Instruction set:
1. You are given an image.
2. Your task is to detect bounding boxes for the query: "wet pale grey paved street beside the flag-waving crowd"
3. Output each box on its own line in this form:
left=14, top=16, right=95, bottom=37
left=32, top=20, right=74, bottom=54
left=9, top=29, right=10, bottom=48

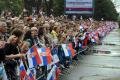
left=62, top=29, right=120, bottom=80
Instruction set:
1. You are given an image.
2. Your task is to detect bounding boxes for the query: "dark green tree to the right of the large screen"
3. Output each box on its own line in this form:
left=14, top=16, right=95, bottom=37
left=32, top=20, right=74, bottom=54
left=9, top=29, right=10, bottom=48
left=94, top=0, right=118, bottom=20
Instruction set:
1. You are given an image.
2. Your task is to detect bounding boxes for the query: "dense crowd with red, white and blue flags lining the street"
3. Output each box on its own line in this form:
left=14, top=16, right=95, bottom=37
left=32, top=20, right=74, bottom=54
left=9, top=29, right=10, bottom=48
left=0, top=11, right=118, bottom=80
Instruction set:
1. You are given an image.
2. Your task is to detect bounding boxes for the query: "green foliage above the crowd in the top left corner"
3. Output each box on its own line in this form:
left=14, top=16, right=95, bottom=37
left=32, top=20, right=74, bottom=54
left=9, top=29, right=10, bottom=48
left=0, top=0, right=23, bottom=15
